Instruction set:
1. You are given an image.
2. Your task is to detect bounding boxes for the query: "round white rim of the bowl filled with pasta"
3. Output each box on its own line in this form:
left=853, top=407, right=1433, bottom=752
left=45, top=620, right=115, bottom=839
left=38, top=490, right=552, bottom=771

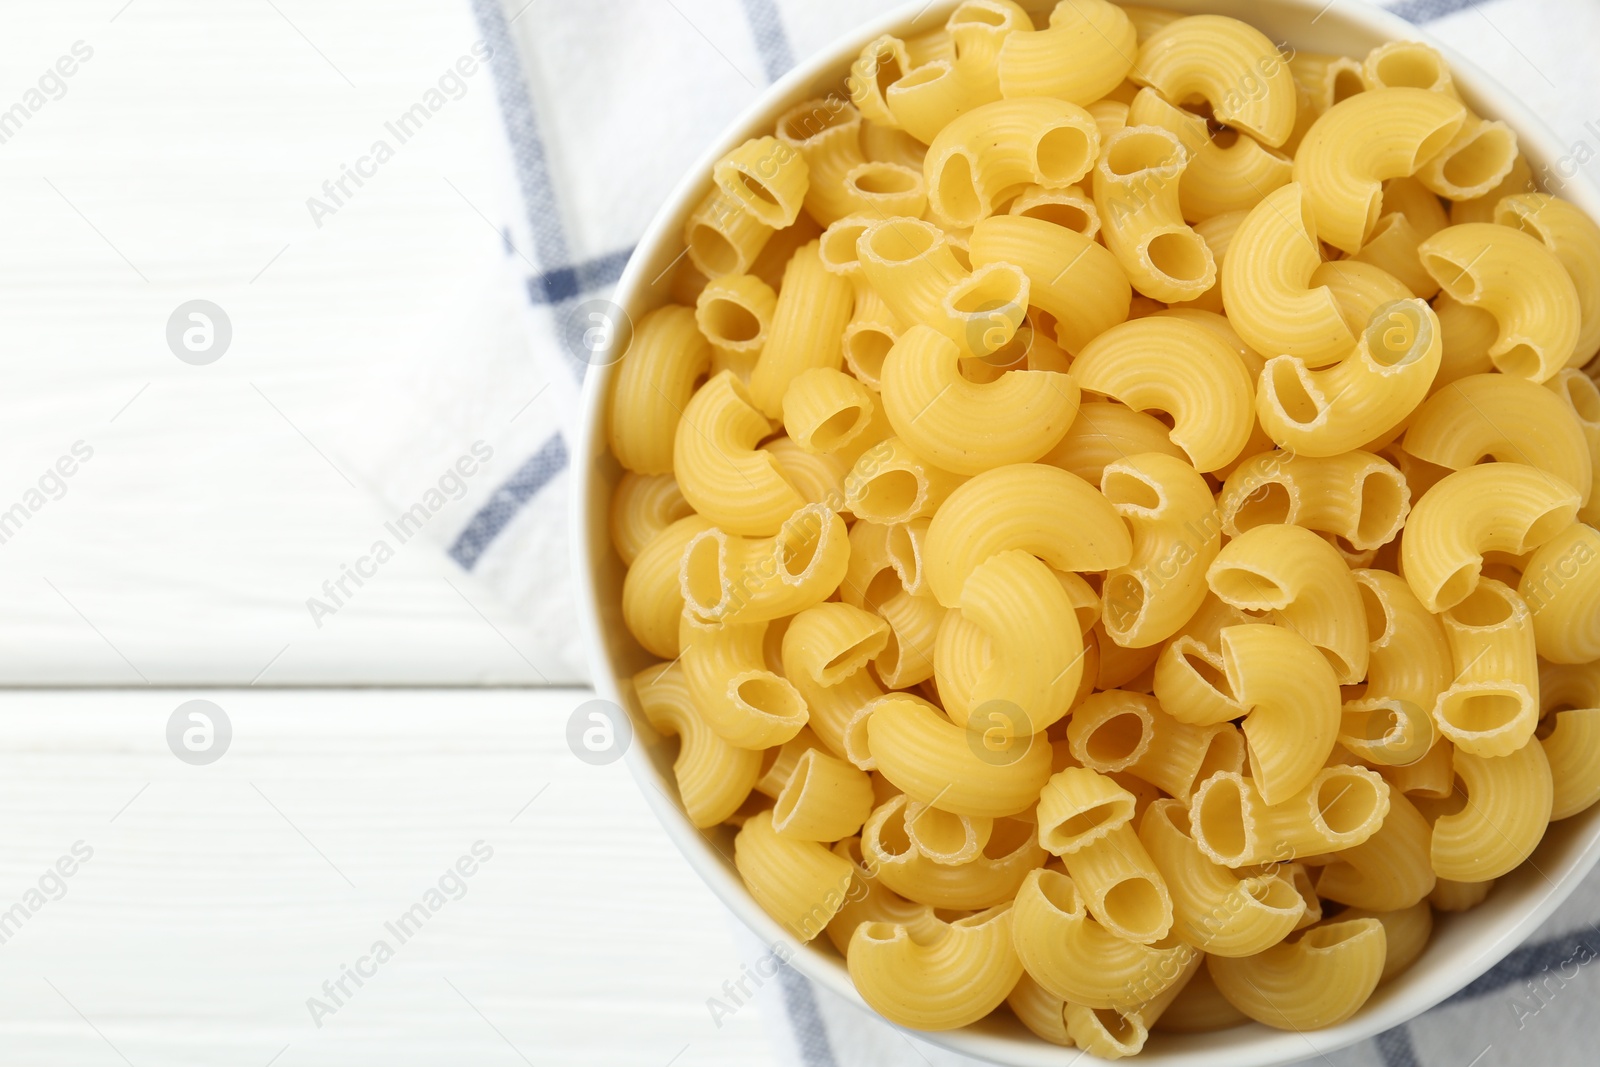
left=570, top=0, right=1600, bottom=1067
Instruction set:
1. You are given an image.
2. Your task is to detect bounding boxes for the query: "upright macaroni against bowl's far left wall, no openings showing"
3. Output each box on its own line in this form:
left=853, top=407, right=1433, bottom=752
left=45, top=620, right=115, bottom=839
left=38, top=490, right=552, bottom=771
left=606, top=307, right=710, bottom=474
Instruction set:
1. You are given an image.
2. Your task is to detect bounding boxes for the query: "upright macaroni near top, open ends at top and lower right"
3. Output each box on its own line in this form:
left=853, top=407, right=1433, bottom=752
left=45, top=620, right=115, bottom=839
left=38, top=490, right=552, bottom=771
left=1094, top=126, right=1216, bottom=302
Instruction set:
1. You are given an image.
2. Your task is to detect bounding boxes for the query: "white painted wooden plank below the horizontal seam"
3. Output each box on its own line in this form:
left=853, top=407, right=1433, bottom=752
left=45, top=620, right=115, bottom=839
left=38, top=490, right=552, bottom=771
left=0, top=689, right=771, bottom=1067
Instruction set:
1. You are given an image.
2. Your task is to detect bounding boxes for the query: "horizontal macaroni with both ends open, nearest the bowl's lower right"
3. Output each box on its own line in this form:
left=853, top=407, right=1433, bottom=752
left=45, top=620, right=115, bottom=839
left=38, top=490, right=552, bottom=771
left=1189, top=763, right=1390, bottom=867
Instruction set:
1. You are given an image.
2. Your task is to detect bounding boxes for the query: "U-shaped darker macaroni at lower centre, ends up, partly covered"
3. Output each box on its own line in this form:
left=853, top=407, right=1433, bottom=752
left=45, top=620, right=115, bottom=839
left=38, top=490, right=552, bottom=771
left=861, top=795, right=1050, bottom=909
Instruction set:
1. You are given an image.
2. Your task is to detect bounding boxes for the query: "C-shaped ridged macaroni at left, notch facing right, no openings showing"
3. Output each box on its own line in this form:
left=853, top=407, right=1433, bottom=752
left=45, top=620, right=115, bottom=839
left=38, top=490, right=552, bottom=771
left=674, top=371, right=805, bottom=536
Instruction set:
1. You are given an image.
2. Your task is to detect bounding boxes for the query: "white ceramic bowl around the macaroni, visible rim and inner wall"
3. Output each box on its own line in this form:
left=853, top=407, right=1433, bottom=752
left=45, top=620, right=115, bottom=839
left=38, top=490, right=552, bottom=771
left=573, top=0, right=1600, bottom=1067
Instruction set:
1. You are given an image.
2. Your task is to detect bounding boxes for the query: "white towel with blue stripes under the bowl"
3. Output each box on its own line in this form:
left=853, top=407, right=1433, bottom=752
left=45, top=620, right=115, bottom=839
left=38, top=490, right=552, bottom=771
left=444, top=0, right=1600, bottom=1067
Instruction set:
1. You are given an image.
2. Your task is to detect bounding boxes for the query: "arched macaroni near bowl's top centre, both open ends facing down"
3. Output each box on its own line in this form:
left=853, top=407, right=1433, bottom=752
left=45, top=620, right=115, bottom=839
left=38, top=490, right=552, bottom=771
left=923, top=96, right=1101, bottom=229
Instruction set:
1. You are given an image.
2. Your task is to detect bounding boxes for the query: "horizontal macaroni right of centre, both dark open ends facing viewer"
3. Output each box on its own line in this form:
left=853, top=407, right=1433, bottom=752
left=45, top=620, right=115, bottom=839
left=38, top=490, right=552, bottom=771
left=1218, top=451, right=1411, bottom=550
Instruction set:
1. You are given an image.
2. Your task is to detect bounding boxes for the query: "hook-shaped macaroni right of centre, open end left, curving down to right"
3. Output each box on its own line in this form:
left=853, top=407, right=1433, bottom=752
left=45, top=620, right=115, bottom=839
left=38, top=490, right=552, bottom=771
left=1206, top=525, right=1368, bottom=684
